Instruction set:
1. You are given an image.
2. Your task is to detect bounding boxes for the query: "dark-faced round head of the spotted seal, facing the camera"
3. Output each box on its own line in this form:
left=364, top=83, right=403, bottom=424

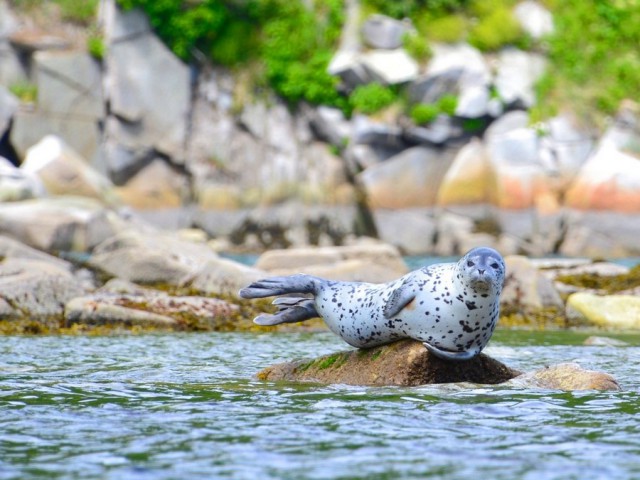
left=458, top=247, right=505, bottom=294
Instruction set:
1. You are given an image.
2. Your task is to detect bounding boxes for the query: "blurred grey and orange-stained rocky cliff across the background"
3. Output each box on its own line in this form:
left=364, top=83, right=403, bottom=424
left=0, top=0, right=640, bottom=256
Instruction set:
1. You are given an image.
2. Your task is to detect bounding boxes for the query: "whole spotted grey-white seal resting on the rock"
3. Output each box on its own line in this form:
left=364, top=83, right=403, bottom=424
left=239, top=247, right=505, bottom=360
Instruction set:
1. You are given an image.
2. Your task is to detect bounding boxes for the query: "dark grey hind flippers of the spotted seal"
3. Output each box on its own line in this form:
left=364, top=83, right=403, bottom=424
left=239, top=274, right=325, bottom=325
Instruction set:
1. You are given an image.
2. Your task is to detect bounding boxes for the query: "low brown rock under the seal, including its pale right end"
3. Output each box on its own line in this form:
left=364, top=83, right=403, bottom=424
left=257, top=340, right=620, bottom=391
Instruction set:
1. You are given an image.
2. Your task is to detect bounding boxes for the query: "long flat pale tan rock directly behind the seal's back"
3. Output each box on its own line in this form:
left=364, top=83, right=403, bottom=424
left=255, top=244, right=408, bottom=283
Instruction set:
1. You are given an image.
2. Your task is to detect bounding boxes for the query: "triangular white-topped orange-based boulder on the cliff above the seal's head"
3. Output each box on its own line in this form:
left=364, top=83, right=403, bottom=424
left=437, top=139, right=494, bottom=207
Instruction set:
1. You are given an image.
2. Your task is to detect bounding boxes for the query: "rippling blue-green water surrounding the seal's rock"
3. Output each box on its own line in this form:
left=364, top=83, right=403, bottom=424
left=0, top=331, right=640, bottom=480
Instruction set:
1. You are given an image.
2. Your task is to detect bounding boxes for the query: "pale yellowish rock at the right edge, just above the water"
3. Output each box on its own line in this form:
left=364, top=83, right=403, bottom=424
left=566, top=292, right=640, bottom=330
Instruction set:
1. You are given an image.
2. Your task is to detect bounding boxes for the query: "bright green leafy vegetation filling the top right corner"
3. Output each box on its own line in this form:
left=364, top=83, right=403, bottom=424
left=534, top=0, right=640, bottom=125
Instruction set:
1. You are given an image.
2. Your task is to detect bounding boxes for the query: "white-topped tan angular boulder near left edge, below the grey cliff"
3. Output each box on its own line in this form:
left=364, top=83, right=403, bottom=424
left=20, top=135, right=118, bottom=205
